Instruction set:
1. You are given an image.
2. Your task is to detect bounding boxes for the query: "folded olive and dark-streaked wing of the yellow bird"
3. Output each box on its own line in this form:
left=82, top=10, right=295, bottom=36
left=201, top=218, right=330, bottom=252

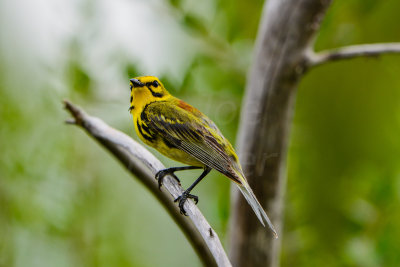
left=141, top=102, right=242, bottom=184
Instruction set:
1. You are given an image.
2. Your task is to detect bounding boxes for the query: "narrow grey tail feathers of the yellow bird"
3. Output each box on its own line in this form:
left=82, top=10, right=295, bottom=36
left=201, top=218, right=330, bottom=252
left=236, top=179, right=278, bottom=238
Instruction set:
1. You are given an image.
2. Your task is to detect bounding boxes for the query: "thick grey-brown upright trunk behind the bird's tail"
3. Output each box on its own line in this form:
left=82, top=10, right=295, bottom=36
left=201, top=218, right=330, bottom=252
left=230, top=0, right=331, bottom=267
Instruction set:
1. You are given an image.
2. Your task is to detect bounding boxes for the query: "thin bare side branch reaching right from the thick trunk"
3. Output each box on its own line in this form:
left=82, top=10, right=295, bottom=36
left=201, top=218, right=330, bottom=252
left=306, top=43, right=400, bottom=67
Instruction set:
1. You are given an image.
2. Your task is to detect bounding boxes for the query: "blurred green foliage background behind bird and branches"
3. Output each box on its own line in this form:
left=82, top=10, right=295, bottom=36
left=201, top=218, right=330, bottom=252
left=0, top=0, right=400, bottom=266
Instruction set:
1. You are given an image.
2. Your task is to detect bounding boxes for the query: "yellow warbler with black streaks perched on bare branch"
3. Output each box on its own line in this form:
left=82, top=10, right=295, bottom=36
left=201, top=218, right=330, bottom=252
left=129, top=76, right=277, bottom=237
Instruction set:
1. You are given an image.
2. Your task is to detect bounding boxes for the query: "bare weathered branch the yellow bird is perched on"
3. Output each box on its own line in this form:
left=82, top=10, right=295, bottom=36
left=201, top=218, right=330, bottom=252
left=64, top=100, right=231, bottom=266
